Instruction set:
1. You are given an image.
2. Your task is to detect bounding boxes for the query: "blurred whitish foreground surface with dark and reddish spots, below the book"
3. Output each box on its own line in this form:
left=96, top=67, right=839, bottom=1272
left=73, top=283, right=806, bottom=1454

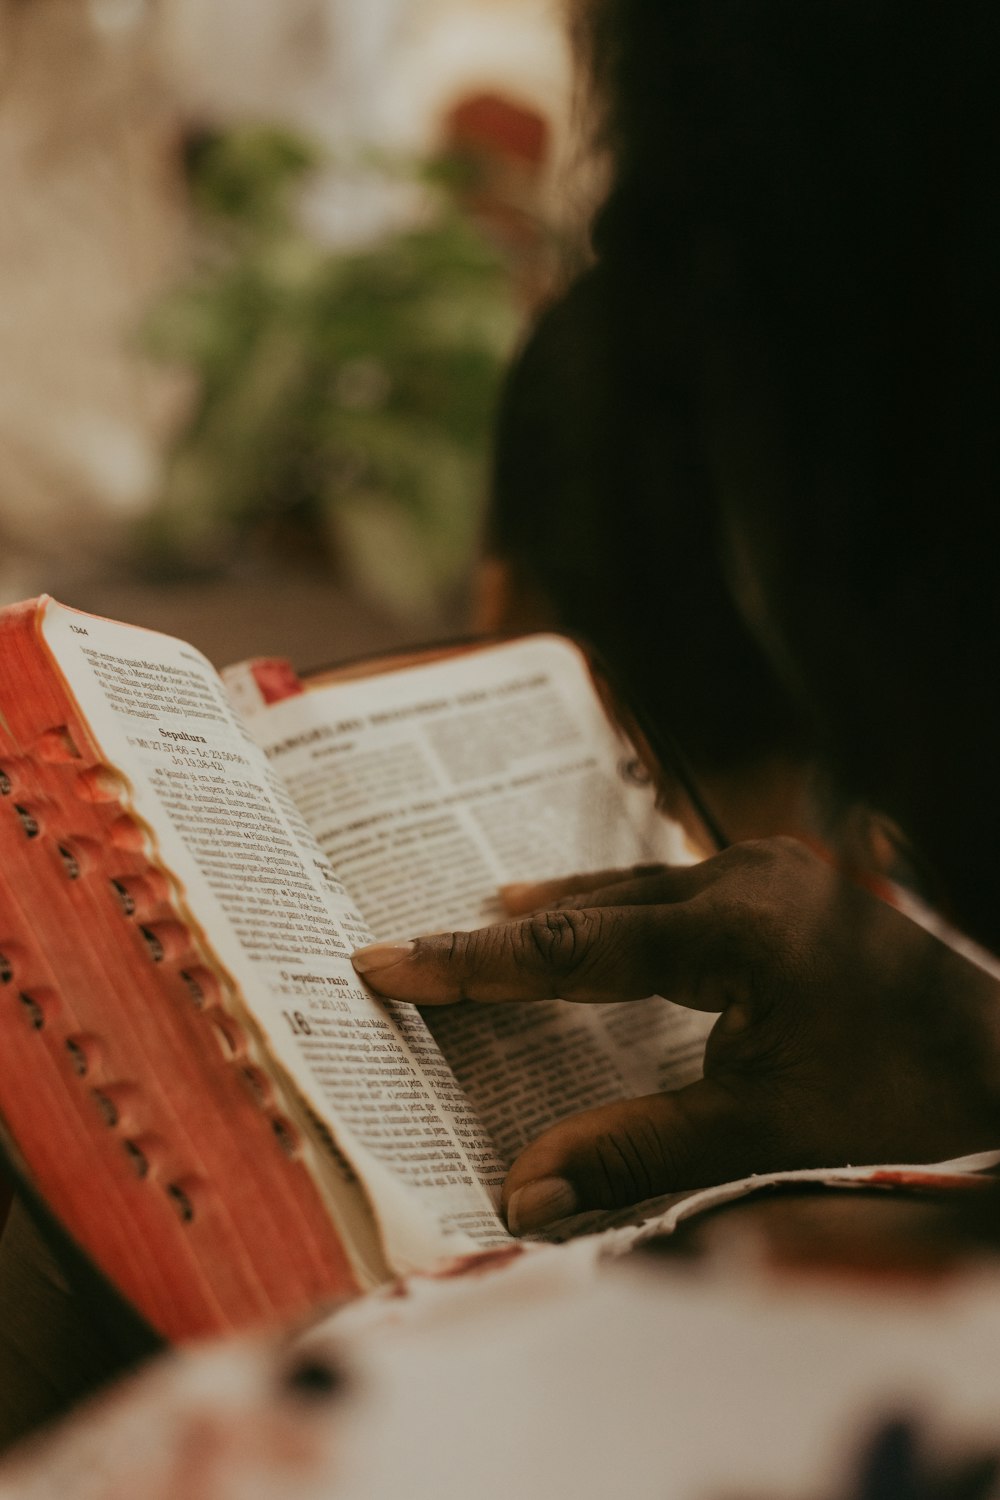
left=0, top=1191, right=1000, bottom=1500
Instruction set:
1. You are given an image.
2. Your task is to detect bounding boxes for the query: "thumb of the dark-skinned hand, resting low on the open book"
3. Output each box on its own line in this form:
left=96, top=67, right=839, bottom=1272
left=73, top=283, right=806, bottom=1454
left=502, top=1079, right=772, bottom=1235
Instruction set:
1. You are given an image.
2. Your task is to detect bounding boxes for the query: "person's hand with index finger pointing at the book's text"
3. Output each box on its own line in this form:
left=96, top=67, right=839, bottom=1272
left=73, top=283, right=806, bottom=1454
left=355, top=839, right=1000, bottom=1232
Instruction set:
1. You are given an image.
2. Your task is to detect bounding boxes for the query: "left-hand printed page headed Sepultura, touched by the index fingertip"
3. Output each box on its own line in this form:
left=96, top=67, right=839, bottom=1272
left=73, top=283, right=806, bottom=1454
left=42, top=600, right=508, bottom=1269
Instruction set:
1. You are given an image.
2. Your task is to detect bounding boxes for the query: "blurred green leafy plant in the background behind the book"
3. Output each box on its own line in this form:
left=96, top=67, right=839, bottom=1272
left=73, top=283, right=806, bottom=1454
left=139, top=128, right=519, bottom=615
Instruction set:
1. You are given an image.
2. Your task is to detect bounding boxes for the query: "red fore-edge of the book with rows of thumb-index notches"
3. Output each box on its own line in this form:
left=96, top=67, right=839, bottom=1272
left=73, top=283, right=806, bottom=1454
left=0, top=606, right=358, bottom=1338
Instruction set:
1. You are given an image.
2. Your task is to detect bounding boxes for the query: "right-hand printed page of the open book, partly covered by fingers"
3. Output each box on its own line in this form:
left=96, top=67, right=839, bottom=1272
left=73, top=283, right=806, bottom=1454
left=235, top=636, right=714, bottom=1163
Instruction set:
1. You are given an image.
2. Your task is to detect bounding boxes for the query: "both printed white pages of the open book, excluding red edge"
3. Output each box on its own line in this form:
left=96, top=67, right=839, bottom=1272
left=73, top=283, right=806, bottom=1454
left=0, top=600, right=711, bottom=1338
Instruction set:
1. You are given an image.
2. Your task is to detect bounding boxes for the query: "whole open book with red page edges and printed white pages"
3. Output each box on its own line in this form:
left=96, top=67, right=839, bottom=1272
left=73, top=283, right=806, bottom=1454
left=0, top=599, right=711, bottom=1338
